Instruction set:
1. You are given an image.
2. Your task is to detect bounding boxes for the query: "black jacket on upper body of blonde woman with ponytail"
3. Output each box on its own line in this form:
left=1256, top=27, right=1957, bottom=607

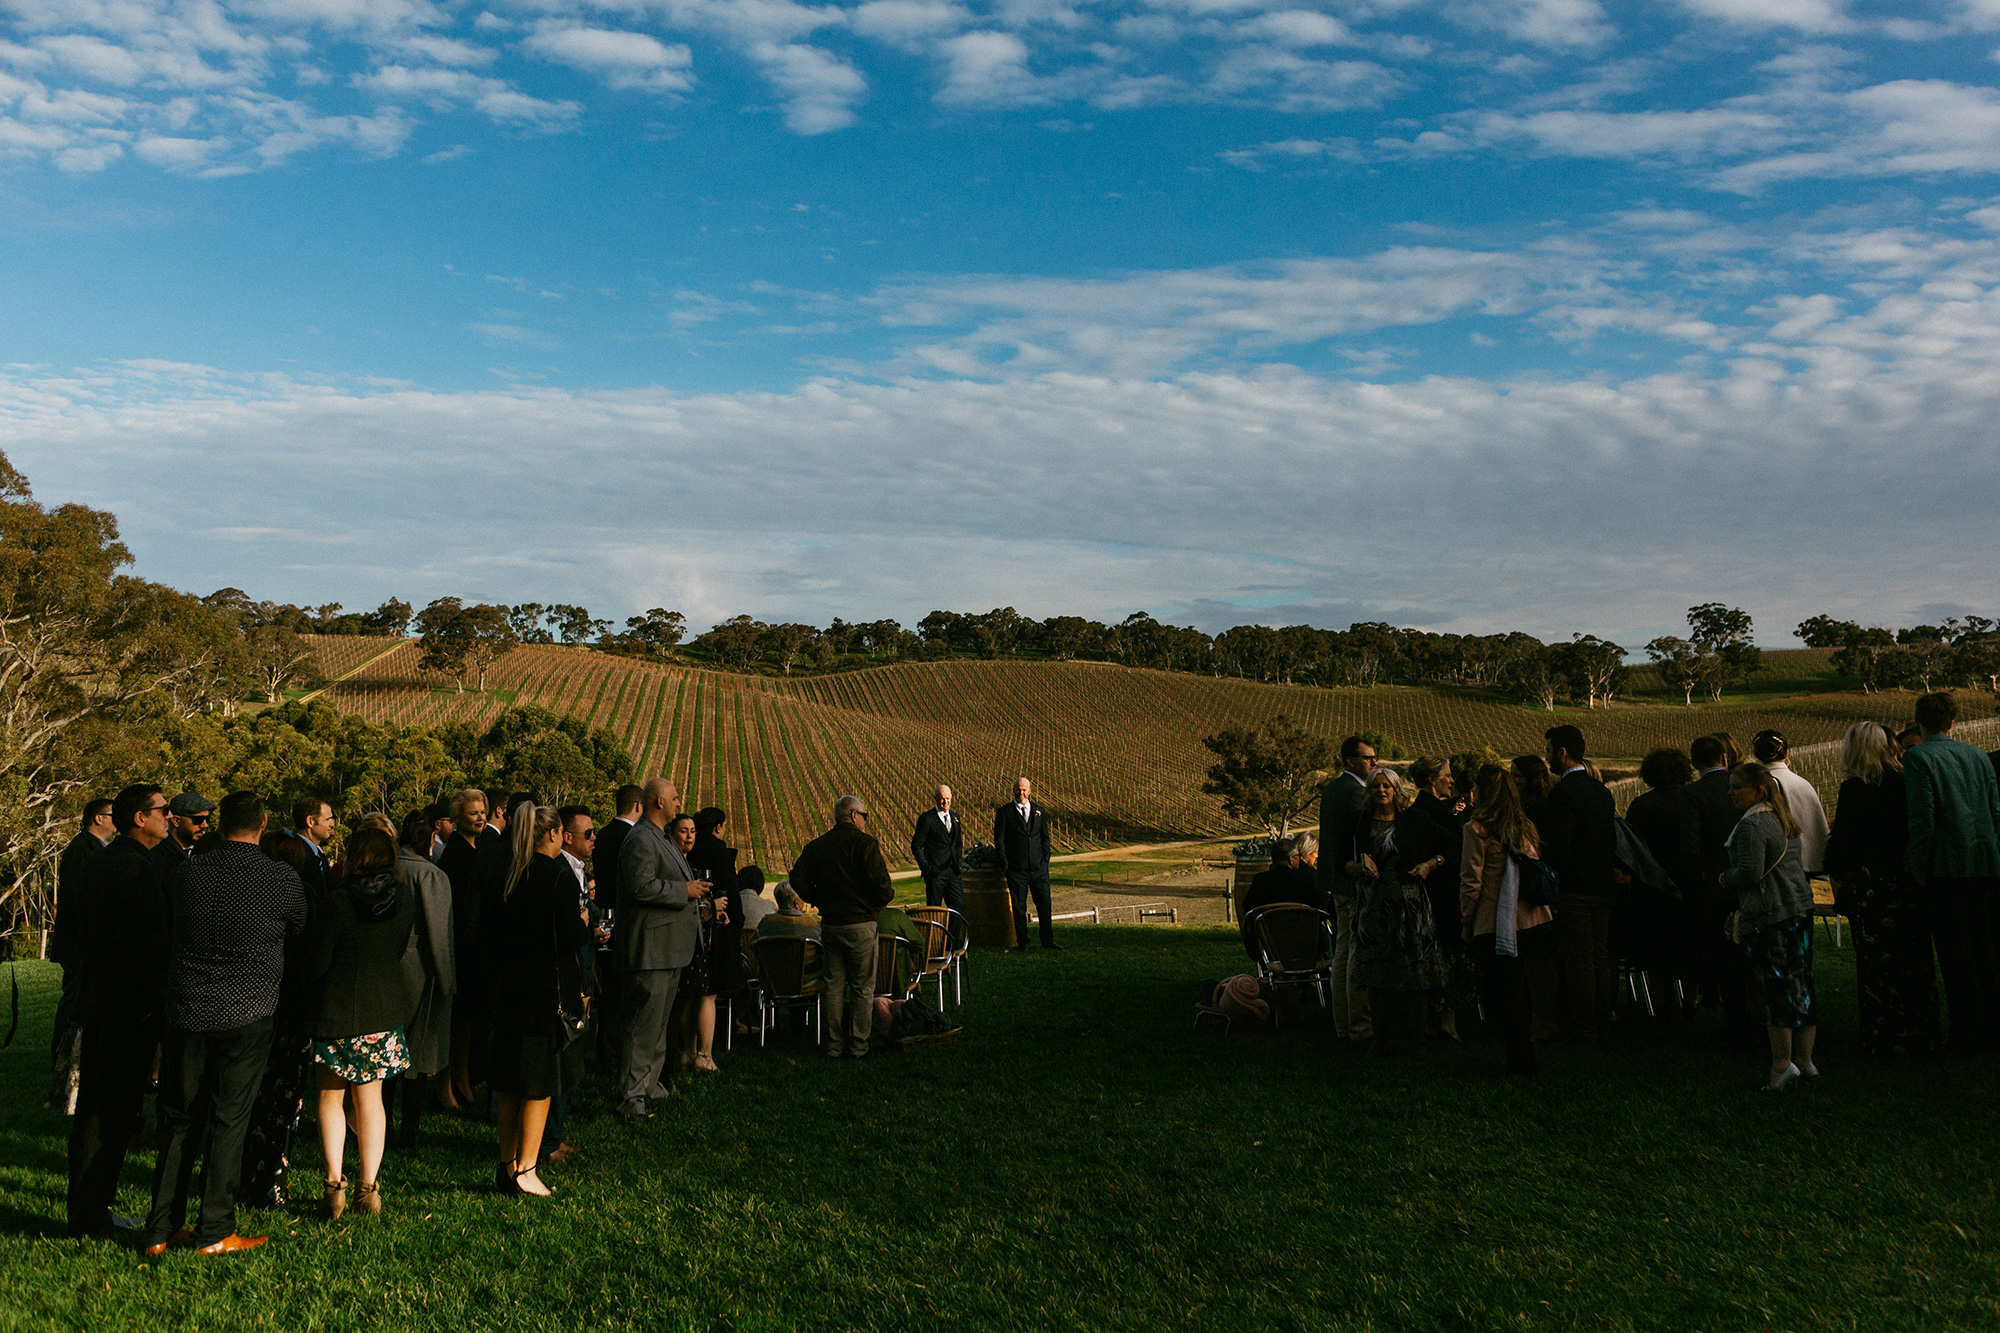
left=492, top=857, right=590, bottom=1037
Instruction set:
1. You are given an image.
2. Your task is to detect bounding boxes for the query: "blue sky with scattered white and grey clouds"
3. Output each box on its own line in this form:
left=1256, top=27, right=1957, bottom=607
left=0, top=0, right=2000, bottom=642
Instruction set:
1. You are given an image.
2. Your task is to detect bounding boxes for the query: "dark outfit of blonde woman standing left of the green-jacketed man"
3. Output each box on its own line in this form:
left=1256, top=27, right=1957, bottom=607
left=1826, top=773, right=1938, bottom=1055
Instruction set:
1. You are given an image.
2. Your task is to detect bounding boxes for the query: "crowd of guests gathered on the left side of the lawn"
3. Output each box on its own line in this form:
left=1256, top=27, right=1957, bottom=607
left=50, top=779, right=924, bottom=1255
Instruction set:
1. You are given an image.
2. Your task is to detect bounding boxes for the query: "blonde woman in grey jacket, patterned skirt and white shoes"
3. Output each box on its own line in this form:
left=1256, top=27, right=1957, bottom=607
left=1722, top=763, right=1820, bottom=1093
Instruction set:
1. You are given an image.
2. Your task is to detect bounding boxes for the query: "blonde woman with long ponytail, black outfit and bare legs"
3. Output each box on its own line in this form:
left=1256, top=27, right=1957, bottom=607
left=486, top=805, right=590, bottom=1197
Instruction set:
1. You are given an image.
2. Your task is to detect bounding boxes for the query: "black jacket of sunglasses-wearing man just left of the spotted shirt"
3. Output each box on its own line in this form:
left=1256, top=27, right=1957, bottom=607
left=76, top=837, right=174, bottom=1020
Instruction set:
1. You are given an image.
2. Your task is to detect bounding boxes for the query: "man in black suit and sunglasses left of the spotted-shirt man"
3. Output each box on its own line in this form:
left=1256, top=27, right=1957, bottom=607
left=70, top=783, right=172, bottom=1235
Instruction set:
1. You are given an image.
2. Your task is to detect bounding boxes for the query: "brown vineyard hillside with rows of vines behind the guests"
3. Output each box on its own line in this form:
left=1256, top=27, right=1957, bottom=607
left=322, top=636, right=1992, bottom=867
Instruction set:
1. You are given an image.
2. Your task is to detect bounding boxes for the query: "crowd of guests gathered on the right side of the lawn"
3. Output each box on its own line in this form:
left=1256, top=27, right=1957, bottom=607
left=1214, top=693, right=2000, bottom=1091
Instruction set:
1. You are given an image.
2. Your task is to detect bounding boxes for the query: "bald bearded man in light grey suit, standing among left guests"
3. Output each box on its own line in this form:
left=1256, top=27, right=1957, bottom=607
left=612, top=779, right=708, bottom=1121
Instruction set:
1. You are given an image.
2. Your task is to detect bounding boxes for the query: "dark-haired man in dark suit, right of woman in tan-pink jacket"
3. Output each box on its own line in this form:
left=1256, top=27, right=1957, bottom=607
left=1540, top=725, right=1618, bottom=1047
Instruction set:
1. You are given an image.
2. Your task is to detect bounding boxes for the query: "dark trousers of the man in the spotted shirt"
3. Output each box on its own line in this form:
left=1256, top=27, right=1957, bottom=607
left=146, top=1019, right=272, bottom=1245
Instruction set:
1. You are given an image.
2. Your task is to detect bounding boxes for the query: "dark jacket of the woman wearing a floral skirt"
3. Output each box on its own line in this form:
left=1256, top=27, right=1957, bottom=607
left=306, top=873, right=424, bottom=1041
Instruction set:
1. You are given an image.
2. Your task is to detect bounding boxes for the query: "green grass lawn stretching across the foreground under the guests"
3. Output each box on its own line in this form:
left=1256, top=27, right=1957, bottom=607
left=0, top=927, right=2000, bottom=1331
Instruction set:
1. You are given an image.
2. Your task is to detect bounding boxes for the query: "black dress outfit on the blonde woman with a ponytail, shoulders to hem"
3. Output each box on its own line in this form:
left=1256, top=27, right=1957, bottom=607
left=486, top=855, right=590, bottom=1101
